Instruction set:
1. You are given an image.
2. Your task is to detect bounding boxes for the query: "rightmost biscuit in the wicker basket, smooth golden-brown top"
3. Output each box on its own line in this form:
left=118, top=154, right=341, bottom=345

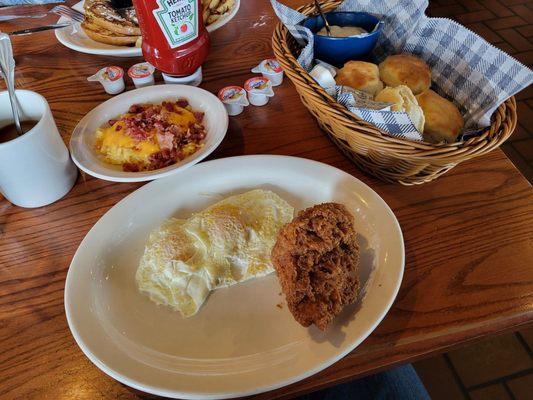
left=416, top=90, right=464, bottom=143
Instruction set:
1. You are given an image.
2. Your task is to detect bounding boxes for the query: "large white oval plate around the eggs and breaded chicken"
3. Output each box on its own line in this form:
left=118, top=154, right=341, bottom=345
left=65, top=155, right=404, bottom=399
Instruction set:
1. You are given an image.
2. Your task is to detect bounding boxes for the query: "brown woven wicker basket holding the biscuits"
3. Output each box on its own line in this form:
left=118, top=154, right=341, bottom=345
left=272, top=0, right=517, bottom=185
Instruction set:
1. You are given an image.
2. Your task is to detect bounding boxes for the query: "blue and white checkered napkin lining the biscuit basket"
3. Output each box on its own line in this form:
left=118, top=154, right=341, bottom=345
left=271, top=0, right=533, bottom=140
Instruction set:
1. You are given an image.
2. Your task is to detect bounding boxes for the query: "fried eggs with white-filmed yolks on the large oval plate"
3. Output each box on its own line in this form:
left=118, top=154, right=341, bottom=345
left=136, top=189, right=294, bottom=317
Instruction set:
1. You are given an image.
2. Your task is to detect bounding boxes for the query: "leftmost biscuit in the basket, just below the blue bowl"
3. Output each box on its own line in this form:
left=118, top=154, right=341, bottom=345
left=335, top=61, right=383, bottom=96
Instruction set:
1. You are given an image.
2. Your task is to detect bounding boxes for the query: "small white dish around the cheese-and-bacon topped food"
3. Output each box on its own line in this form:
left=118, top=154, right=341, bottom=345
left=70, top=85, right=228, bottom=182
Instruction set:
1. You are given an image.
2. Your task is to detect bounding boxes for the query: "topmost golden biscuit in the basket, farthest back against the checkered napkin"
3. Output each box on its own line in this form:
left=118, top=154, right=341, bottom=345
left=379, top=54, right=431, bottom=95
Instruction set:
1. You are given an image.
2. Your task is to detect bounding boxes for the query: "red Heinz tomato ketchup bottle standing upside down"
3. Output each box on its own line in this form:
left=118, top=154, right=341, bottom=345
left=133, top=0, right=209, bottom=81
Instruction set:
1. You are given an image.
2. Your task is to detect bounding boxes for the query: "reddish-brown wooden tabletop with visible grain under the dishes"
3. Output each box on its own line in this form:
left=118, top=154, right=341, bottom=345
left=0, top=0, right=533, bottom=399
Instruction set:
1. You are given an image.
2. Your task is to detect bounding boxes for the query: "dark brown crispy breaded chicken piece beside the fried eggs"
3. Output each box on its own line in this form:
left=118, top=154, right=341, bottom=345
left=272, top=203, right=359, bottom=330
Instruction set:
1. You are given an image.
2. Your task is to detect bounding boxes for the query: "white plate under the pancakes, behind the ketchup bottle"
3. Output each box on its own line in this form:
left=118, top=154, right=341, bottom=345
left=55, top=0, right=241, bottom=57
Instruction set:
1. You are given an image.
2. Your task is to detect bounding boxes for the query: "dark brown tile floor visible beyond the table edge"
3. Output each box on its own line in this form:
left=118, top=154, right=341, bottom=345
left=414, top=0, right=533, bottom=400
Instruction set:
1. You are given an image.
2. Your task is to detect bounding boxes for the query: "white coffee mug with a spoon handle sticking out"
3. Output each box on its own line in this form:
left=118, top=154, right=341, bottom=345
left=0, top=90, right=78, bottom=208
